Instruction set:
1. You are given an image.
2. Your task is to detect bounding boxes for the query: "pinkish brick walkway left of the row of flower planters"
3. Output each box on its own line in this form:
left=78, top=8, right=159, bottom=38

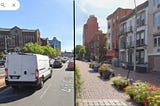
left=76, top=61, right=136, bottom=106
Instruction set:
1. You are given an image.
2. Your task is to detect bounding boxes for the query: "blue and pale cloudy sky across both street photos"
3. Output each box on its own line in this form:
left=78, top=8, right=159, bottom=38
left=0, top=0, right=146, bottom=52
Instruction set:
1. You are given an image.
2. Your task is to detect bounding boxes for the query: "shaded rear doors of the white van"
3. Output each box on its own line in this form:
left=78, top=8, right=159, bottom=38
left=7, top=55, right=36, bottom=82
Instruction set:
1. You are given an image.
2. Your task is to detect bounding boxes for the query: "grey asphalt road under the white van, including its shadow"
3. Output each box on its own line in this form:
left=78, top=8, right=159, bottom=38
left=0, top=62, right=74, bottom=106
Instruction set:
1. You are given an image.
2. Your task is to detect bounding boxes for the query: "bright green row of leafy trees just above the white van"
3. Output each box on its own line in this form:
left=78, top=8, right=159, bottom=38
left=23, top=43, right=59, bottom=57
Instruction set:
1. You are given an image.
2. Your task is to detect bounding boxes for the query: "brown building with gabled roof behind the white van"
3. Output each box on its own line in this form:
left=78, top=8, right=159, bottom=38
left=0, top=26, right=41, bottom=51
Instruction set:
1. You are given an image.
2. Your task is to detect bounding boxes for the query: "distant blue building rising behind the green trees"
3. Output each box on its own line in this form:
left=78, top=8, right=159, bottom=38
left=49, top=37, right=61, bottom=52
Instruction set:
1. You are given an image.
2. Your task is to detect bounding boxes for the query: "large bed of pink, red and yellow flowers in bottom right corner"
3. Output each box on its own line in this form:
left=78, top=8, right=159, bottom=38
left=125, top=81, right=160, bottom=106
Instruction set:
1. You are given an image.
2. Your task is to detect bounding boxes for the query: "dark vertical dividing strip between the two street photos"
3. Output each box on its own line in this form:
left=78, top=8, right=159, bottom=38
left=73, top=0, right=76, bottom=106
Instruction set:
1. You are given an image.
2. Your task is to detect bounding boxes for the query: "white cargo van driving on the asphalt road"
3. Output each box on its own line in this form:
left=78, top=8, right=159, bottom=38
left=5, top=53, right=52, bottom=88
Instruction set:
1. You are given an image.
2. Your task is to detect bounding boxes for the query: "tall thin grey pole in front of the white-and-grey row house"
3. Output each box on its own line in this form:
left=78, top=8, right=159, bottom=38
left=133, top=0, right=137, bottom=81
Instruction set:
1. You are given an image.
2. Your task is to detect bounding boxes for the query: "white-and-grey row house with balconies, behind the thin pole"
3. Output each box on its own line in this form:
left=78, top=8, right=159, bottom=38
left=119, top=1, right=148, bottom=71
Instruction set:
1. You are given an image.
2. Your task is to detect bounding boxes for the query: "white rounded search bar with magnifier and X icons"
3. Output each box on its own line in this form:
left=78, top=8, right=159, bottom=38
left=0, top=0, right=20, bottom=10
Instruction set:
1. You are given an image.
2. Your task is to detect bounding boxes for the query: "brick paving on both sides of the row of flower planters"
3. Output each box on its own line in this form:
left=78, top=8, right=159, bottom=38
left=76, top=61, right=160, bottom=106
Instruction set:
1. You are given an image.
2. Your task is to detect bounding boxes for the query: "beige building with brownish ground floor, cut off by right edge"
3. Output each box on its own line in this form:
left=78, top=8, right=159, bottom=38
left=148, top=0, right=160, bottom=71
